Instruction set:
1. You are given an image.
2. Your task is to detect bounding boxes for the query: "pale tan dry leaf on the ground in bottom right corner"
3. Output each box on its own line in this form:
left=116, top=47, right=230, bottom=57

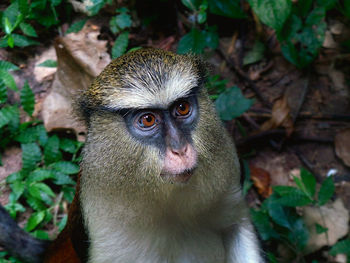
left=303, top=199, right=349, bottom=253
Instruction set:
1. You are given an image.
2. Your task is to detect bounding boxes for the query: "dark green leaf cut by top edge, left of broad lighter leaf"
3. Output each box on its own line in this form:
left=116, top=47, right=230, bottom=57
left=208, top=0, right=246, bottom=18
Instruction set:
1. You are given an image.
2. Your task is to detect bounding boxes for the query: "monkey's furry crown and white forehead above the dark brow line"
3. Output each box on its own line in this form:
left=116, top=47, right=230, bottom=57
left=86, top=49, right=205, bottom=109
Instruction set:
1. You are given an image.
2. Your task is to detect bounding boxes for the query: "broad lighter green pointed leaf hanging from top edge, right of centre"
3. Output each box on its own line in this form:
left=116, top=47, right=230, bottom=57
left=248, top=0, right=292, bottom=31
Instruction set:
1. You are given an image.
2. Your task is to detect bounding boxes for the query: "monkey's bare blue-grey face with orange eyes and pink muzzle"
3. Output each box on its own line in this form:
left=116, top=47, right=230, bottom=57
left=123, top=90, right=198, bottom=182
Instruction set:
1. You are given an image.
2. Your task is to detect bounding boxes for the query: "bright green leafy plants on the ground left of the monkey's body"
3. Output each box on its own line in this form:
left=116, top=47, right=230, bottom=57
left=0, top=61, right=82, bottom=245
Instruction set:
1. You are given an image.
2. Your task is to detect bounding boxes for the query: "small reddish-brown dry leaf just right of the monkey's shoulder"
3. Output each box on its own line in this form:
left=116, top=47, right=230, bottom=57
left=249, top=166, right=272, bottom=198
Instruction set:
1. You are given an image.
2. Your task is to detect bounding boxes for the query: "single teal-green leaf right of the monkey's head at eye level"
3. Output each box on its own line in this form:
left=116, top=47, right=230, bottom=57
left=215, top=86, right=254, bottom=121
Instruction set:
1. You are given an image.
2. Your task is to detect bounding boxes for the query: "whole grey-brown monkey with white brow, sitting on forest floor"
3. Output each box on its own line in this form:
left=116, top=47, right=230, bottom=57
left=0, top=48, right=264, bottom=263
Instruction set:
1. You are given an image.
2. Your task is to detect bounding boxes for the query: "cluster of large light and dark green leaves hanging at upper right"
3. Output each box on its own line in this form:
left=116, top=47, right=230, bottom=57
left=248, top=0, right=332, bottom=69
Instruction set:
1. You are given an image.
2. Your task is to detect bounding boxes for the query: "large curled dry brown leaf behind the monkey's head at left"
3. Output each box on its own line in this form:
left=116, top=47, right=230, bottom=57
left=42, top=22, right=111, bottom=140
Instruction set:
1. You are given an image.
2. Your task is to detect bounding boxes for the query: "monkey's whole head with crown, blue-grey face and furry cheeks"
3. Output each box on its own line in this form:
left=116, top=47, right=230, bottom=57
left=80, top=49, right=238, bottom=200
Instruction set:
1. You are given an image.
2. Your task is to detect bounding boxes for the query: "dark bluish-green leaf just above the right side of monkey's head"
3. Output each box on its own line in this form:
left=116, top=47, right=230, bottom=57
left=177, top=28, right=207, bottom=54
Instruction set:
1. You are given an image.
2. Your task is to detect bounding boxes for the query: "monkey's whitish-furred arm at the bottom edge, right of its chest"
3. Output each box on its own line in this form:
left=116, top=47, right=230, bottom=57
left=224, top=222, right=264, bottom=263
